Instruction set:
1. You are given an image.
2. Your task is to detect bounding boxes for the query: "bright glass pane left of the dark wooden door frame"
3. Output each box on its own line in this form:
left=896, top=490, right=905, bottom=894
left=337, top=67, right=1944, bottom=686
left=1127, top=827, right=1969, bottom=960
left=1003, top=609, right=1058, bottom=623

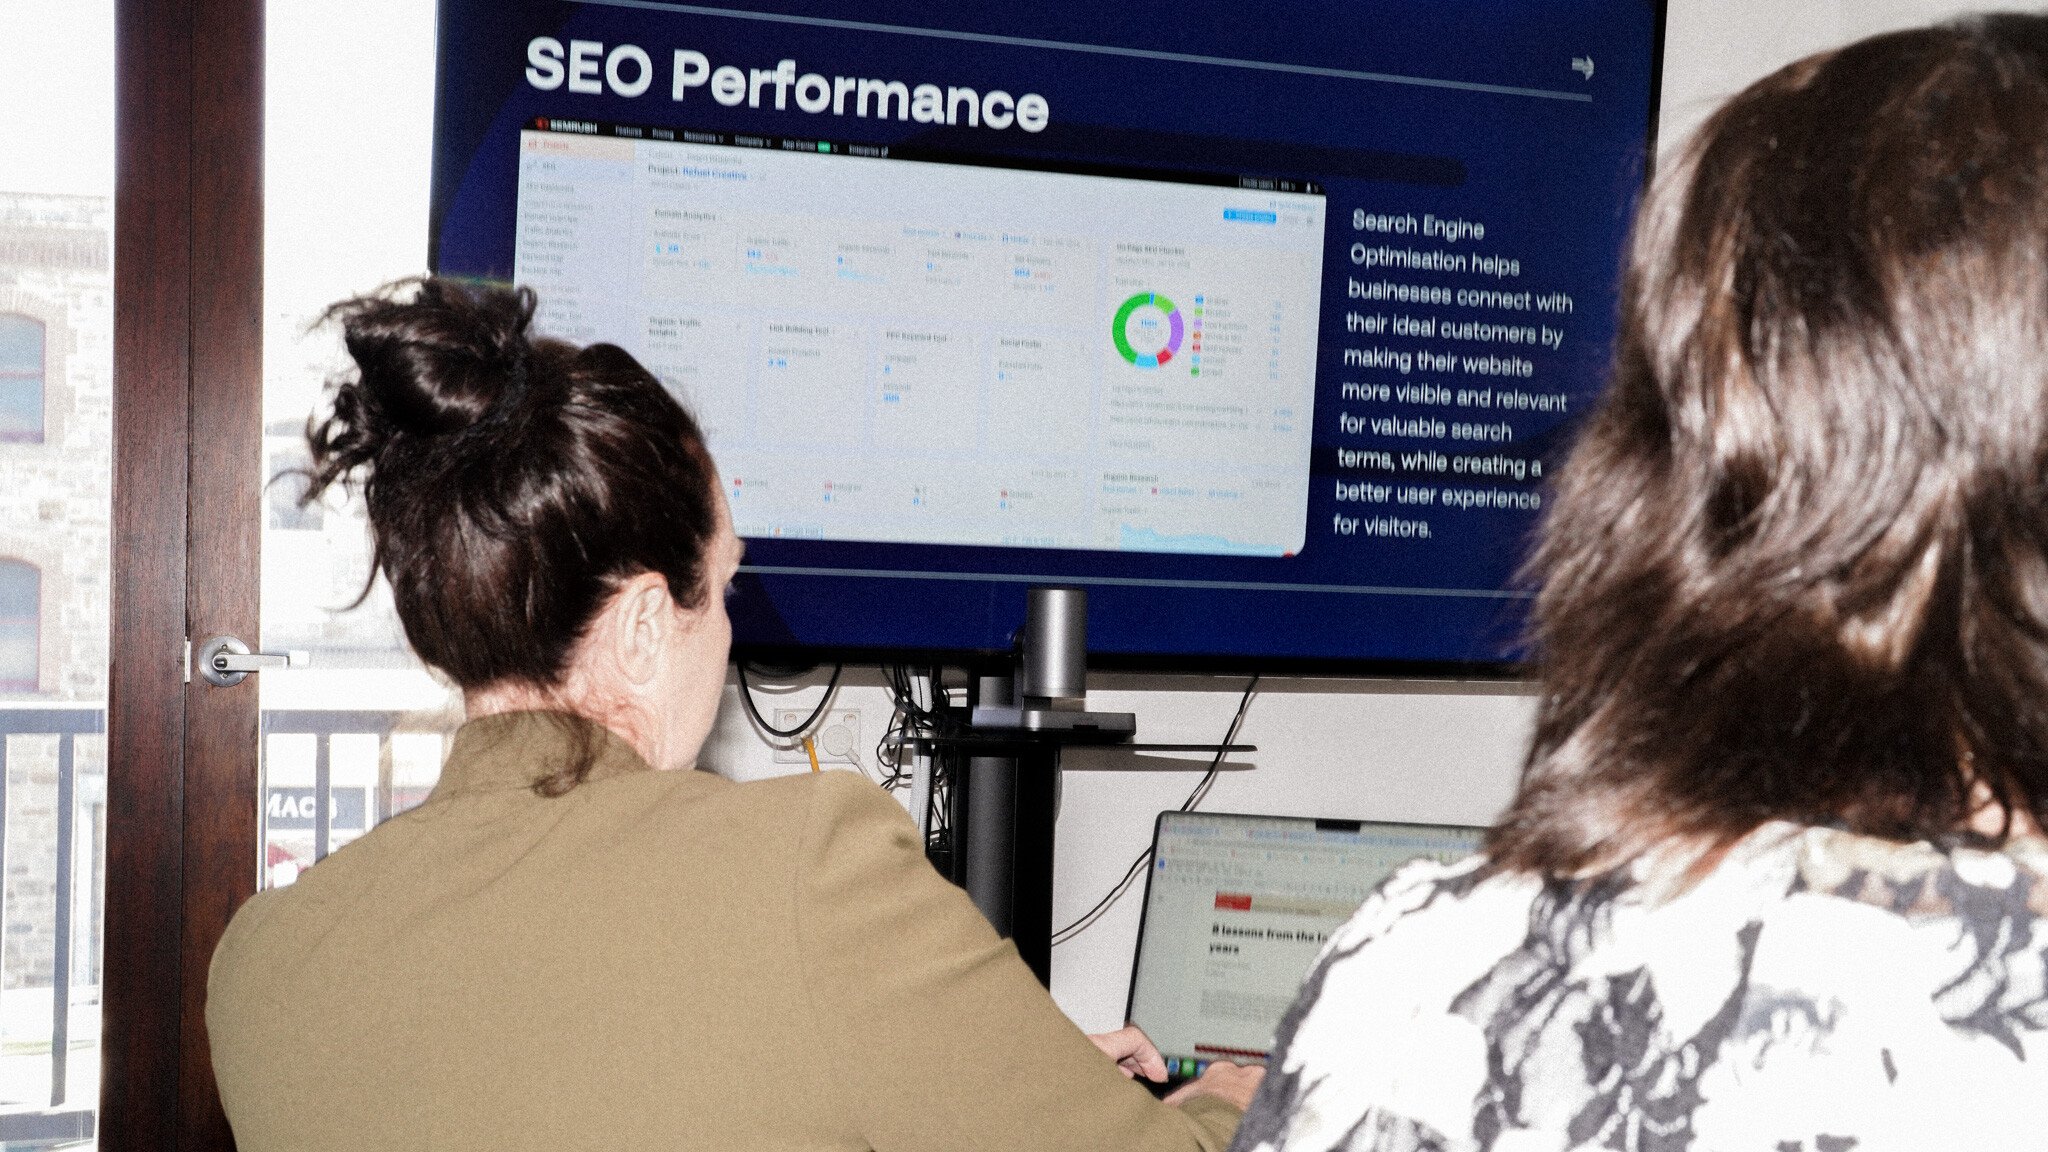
left=0, top=0, right=115, bottom=1131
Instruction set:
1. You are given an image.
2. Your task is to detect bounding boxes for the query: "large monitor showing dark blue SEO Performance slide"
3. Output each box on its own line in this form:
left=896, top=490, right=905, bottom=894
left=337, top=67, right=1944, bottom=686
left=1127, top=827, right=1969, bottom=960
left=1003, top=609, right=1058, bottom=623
left=432, top=0, right=1663, bottom=672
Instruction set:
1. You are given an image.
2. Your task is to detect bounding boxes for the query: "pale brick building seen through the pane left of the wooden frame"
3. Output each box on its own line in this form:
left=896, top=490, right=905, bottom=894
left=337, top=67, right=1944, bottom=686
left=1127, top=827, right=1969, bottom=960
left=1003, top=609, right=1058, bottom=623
left=0, top=193, right=113, bottom=988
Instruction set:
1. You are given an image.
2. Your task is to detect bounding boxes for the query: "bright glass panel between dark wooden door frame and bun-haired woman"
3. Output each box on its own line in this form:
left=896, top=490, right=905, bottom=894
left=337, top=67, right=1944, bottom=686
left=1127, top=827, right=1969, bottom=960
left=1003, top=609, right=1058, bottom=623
left=258, top=0, right=448, bottom=888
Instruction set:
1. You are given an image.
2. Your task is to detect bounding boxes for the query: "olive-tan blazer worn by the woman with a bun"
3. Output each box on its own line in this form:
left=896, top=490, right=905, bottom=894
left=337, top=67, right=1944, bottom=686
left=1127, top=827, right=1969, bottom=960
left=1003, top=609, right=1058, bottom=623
left=207, top=713, right=1237, bottom=1152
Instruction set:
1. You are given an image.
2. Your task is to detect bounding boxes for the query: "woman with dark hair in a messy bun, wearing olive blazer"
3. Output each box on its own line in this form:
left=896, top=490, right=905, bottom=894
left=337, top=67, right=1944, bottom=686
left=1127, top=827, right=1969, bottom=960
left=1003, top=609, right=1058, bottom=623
left=207, top=279, right=1260, bottom=1152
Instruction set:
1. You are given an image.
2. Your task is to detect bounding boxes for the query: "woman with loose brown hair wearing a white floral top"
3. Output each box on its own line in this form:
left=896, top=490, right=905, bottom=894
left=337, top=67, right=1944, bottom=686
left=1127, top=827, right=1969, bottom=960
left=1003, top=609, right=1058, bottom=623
left=1235, top=16, right=2048, bottom=1152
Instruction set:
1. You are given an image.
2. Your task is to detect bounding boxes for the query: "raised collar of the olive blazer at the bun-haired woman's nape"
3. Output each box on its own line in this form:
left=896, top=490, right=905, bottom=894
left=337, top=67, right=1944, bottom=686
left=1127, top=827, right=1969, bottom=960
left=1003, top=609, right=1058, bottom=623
left=426, top=711, right=653, bottom=801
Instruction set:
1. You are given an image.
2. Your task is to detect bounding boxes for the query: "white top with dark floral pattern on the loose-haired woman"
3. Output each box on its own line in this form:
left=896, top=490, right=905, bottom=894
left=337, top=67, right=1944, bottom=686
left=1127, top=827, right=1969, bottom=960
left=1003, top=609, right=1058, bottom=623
left=1231, top=824, right=2048, bottom=1152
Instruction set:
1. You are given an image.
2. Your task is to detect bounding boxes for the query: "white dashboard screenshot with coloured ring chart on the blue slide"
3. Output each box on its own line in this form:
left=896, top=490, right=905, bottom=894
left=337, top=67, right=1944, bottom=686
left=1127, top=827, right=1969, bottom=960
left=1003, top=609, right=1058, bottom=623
left=514, top=125, right=1325, bottom=556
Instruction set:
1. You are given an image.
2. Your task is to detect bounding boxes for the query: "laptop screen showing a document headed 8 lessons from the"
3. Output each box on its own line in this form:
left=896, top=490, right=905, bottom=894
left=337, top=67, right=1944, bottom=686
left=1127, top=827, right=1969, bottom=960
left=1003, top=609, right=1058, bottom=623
left=1128, top=812, right=1487, bottom=1076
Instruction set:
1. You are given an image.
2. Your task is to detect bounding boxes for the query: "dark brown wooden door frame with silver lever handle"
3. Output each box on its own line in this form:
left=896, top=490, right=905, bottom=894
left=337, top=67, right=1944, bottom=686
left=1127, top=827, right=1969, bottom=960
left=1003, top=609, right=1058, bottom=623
left=98, top=0, right=264, bottom=1152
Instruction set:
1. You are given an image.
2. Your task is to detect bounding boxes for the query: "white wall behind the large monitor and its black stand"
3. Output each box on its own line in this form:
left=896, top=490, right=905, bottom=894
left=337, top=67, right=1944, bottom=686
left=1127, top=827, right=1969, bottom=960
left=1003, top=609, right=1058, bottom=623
left=707, top=0, right=1976, bottom=1031
